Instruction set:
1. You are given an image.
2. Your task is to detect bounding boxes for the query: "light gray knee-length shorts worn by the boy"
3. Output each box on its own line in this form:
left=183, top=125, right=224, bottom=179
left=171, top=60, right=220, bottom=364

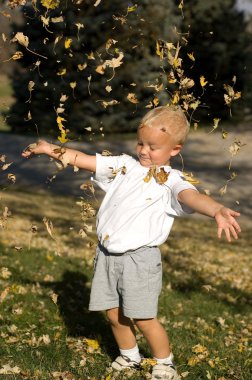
left=89, top=246, right=162, bottom=319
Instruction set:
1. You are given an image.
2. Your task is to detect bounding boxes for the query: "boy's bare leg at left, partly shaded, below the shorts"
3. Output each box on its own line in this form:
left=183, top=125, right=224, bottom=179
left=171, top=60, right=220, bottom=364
left=106, top=307, right=136, bottom=350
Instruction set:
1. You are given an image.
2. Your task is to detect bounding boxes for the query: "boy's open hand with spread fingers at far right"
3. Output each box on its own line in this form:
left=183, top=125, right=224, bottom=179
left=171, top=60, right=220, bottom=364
left=214, top=206, right=241, bottom=242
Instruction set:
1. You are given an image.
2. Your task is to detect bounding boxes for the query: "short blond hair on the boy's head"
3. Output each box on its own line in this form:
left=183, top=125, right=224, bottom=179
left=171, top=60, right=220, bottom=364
left=139, top=106, right=190, bottom=144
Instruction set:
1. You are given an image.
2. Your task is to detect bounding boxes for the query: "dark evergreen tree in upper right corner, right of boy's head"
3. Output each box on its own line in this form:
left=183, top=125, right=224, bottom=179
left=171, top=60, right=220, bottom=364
left=177, top=0, right=251, bottom=119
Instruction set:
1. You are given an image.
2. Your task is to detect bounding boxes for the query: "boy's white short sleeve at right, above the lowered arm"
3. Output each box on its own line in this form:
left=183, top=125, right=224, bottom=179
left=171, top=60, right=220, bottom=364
left=166, top=170, right=198, bottom=216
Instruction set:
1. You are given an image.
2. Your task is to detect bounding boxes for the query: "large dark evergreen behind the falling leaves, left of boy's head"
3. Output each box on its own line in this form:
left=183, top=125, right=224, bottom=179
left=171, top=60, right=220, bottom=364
left=8, top=0, right=177, bottom=135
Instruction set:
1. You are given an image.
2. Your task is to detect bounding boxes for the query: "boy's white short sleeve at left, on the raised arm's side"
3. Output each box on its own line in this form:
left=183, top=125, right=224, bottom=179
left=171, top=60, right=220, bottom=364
left=93, top=154, right=131, bottom=192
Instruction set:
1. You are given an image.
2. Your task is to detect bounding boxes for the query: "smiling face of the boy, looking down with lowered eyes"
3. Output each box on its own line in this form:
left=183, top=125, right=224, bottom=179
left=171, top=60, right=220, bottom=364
left=136, top=126, right=182, bottom=167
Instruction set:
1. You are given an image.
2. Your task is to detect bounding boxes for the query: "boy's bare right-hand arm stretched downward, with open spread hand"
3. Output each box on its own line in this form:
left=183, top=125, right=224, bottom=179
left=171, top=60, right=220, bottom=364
left=178, top=189, right=241, bottom=242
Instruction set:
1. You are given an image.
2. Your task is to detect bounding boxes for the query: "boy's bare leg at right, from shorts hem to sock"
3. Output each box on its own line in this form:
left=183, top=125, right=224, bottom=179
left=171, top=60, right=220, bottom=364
left=135, top=318, right=171, bottom=359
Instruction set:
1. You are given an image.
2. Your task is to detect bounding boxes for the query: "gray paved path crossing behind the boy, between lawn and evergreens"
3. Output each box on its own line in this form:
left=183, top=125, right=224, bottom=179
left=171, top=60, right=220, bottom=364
left=0, top=130, right=252, bottom=227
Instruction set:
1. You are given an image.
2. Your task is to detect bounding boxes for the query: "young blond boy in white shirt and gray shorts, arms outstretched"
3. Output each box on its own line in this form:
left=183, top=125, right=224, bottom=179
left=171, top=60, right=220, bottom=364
left=22, top=106, right=241, bottom=380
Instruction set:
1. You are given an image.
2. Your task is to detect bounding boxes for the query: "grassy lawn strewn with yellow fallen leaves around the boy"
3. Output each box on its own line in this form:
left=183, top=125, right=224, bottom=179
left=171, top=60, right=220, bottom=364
left=0, top=190, right=252, bottom=380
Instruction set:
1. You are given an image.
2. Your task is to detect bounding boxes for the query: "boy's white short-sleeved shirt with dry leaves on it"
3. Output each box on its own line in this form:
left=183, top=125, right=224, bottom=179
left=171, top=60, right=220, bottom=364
left=95, top=154, right=197, bottom=253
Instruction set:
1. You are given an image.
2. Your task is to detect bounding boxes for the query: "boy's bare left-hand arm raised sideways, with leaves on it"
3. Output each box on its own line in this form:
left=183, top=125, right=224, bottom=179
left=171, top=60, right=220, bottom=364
left=22, top=140, right=96, bottom=172
